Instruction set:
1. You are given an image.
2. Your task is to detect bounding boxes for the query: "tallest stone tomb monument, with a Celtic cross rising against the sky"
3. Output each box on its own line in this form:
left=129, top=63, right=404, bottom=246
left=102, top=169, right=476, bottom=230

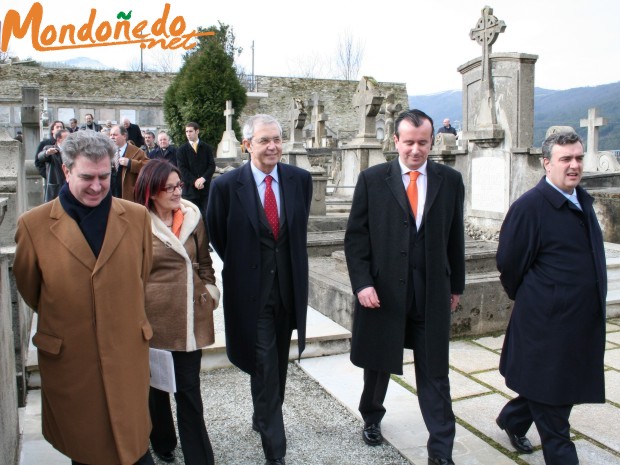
left=454, top=7, right=543, bottom=237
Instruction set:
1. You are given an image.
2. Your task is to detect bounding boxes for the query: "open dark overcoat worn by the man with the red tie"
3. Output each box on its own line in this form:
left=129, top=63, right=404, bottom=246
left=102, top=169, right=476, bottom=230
left=207, top=162, right=312, bottom=374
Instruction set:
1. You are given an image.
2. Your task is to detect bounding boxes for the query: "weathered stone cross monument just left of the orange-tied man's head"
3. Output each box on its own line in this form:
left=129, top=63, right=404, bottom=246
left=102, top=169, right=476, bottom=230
left=334, top=76, right=386, bottom=197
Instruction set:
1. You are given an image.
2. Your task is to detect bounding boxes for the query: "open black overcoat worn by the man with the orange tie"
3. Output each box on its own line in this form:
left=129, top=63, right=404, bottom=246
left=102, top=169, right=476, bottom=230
left=344, top=159, right=465, bottom=376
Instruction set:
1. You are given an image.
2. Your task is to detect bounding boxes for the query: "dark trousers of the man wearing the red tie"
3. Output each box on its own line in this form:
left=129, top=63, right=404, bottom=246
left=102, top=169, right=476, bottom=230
left=250, top=285, right=293, bottom=460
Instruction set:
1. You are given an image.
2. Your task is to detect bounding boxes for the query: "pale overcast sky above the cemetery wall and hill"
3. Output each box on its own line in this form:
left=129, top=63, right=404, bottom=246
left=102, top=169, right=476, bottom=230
left=0, top=0, right=620, bottom=95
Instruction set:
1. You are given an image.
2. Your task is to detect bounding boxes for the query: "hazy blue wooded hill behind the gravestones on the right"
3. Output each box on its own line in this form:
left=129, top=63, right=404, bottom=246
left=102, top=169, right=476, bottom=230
left=409, top=82, right=620, bottom=150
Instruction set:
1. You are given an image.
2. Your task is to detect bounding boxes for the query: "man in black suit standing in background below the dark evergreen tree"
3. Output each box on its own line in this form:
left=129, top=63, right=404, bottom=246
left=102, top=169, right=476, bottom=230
left=177, top=122, right=215, bottom=226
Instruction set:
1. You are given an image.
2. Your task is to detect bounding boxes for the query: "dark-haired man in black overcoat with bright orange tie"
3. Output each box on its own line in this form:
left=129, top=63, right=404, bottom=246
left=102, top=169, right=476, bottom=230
left=344, top=110, right=465, bottom=465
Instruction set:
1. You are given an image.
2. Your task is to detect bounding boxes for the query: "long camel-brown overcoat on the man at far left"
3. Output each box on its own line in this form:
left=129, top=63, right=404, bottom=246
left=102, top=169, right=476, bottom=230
left=13, top=199, right=153, bottom=465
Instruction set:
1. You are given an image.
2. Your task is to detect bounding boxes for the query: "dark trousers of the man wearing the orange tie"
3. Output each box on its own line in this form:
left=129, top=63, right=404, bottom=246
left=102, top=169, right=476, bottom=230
left=359, top=319, right=456, bottom=459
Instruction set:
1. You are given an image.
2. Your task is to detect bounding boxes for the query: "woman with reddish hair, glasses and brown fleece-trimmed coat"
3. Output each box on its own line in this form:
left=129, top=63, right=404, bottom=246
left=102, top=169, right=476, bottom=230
left=135, top=160, right=219, bottom=465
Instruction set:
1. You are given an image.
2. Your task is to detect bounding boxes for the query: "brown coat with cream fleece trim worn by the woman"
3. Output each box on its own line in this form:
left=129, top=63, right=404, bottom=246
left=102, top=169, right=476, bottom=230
left=146, top=200, right=220, bottom=352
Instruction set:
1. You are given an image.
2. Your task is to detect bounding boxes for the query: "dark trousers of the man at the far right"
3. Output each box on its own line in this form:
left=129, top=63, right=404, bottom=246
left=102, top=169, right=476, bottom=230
left=499, top=396, right=579, bottom=465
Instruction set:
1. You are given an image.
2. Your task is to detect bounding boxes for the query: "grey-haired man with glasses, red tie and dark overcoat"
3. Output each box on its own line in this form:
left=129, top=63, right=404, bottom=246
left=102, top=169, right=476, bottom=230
left=207, top=115, right=312, bottom=464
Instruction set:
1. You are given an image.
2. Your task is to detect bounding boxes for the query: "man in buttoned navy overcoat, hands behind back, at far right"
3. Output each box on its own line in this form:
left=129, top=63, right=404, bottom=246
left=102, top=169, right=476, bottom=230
left=496, top=132, right=607, bottom=465
